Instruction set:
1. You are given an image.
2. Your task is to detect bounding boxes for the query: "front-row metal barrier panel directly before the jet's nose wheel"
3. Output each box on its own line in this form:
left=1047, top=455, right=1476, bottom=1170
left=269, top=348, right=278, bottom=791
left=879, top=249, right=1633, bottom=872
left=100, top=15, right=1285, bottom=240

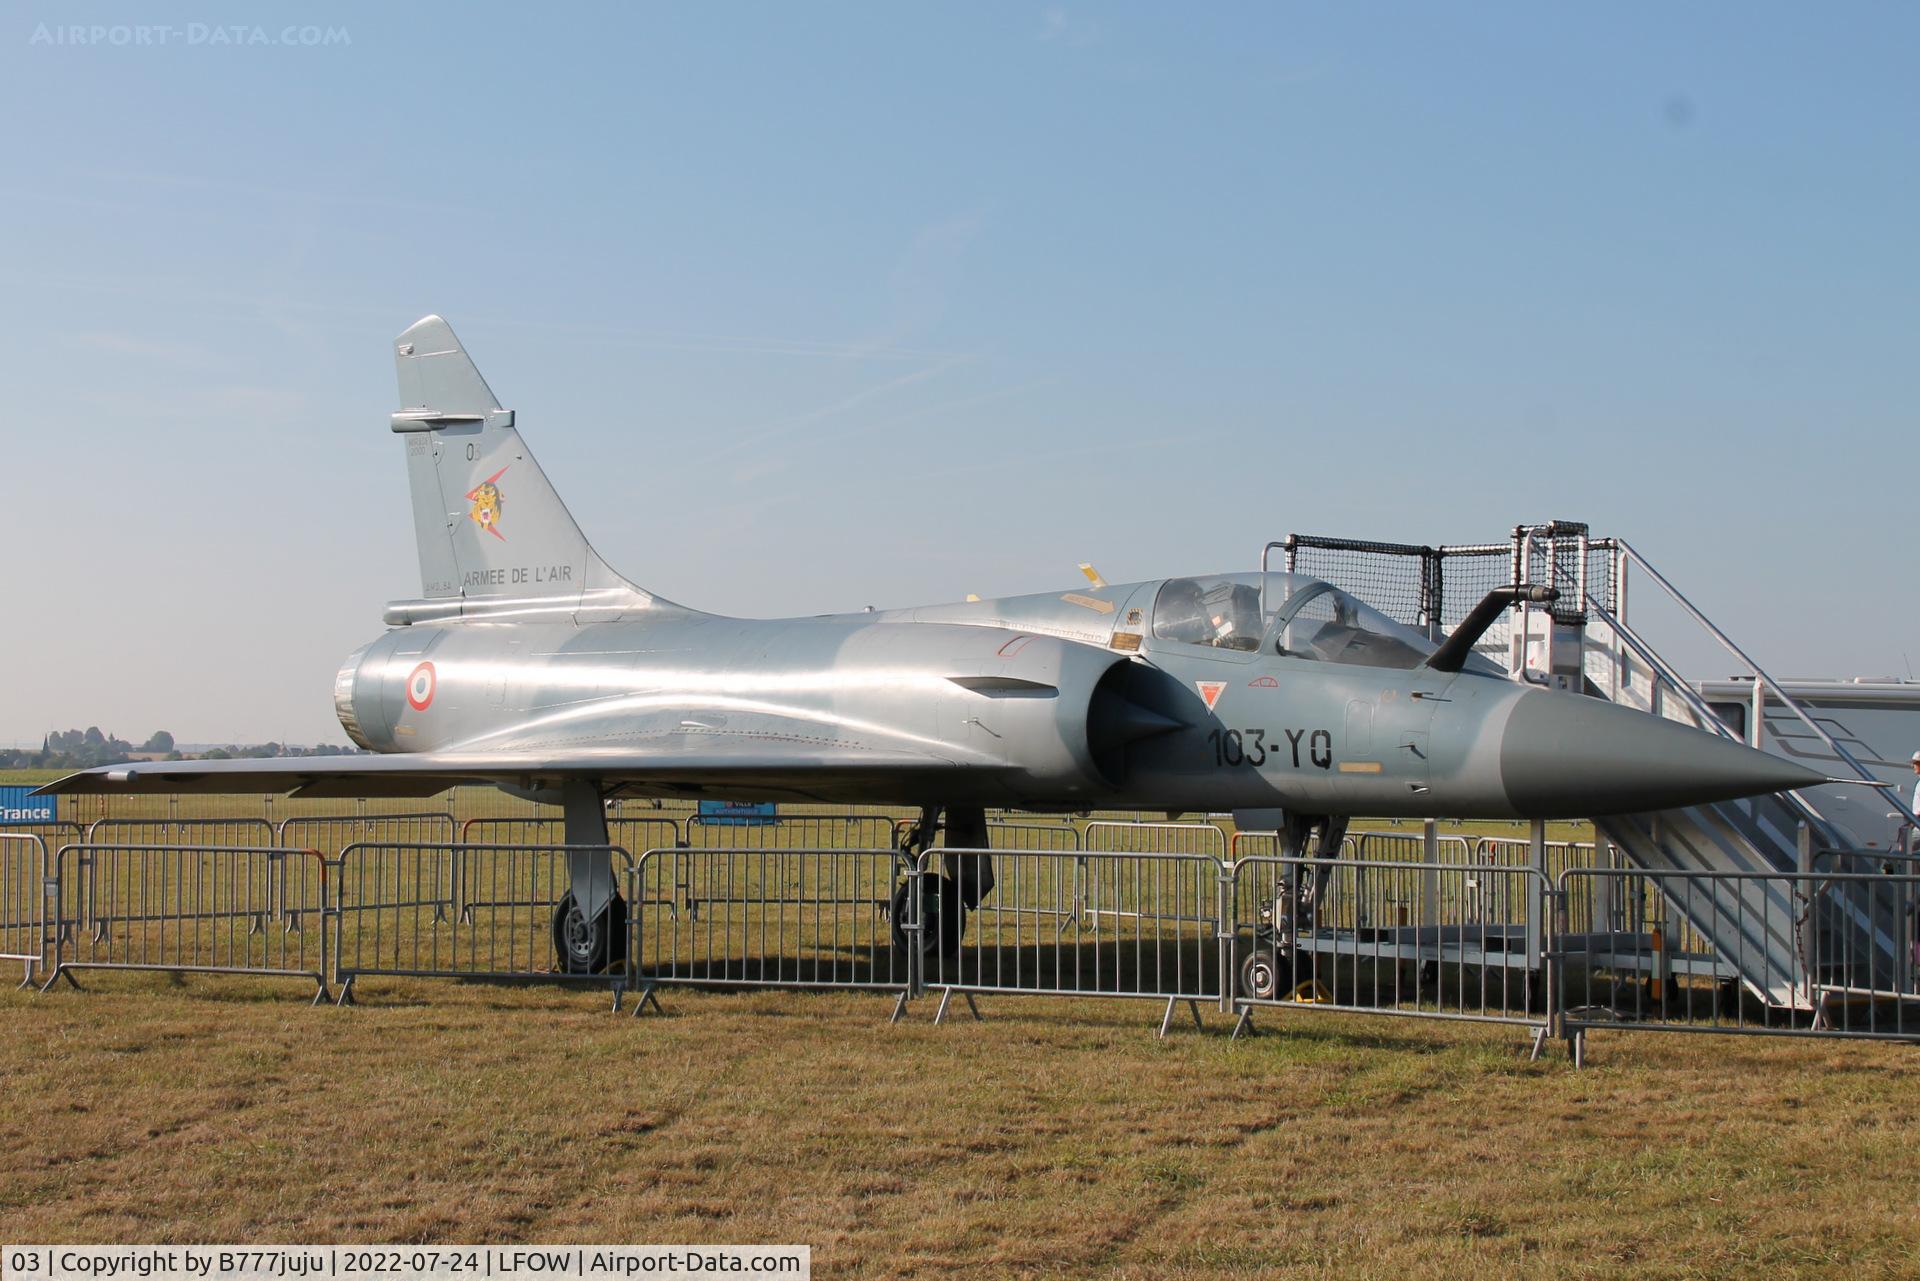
left=1231, top=855, right=1551, bottom=1029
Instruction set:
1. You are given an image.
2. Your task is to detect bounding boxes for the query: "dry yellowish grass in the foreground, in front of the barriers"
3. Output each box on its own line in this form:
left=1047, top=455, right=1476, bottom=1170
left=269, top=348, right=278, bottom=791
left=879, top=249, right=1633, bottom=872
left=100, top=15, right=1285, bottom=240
left=0, top=976, right=1920, bottom=1279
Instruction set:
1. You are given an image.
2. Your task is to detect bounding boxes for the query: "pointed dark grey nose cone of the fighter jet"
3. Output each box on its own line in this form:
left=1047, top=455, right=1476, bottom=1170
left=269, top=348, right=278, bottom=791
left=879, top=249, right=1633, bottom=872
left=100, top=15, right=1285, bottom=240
left=1500, top=689, right=1824, bottom=818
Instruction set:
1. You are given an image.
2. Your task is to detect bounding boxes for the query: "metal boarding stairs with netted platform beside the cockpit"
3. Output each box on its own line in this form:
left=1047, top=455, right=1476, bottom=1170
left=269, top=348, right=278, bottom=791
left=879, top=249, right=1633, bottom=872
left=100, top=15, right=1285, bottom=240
left=1261, top=520, right=1920, bottom=1020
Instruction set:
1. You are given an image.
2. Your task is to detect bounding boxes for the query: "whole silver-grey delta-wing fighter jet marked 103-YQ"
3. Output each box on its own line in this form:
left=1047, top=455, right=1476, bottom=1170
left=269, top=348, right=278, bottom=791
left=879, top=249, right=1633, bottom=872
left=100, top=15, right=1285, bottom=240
left=44, top=317, right=1822, bottom=970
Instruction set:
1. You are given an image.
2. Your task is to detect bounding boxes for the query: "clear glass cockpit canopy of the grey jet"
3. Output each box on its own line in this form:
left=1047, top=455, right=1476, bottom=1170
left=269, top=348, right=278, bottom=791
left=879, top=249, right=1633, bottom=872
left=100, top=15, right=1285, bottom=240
left=1154, top=574, right=1494, bottom=672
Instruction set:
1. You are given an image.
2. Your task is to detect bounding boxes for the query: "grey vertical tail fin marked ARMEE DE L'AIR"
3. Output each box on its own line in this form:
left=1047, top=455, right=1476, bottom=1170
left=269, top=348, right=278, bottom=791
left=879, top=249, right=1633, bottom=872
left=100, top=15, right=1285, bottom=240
left=390, top=315, right=657, bottom=622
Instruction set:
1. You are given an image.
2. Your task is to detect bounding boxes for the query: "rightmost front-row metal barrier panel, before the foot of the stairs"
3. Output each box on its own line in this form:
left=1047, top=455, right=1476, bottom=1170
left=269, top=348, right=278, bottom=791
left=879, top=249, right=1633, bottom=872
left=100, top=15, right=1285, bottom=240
left=1555, top=868, right=1920, bottom=1062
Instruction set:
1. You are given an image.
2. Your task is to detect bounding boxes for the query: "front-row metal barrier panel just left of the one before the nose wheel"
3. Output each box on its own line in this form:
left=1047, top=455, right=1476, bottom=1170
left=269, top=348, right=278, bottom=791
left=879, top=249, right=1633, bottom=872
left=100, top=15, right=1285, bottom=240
left=916, top=845, right=1223, bottom=1003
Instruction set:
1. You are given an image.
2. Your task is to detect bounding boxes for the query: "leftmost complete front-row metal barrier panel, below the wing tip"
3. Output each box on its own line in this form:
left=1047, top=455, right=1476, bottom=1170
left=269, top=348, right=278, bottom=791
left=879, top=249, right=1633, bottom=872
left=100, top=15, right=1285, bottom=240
left=46, top=843, right=328, bottom=995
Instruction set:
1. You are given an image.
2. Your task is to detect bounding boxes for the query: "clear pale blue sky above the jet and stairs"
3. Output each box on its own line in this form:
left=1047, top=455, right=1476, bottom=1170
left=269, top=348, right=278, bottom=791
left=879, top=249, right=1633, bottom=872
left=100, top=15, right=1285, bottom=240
left=0, top=4, right=1920, bottom=741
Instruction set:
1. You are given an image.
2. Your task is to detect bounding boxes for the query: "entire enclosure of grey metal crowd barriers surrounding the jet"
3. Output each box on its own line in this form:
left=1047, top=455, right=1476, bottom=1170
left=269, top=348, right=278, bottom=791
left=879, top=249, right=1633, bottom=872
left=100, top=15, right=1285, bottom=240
left=15, top=814, right=1920, bottom=1062
